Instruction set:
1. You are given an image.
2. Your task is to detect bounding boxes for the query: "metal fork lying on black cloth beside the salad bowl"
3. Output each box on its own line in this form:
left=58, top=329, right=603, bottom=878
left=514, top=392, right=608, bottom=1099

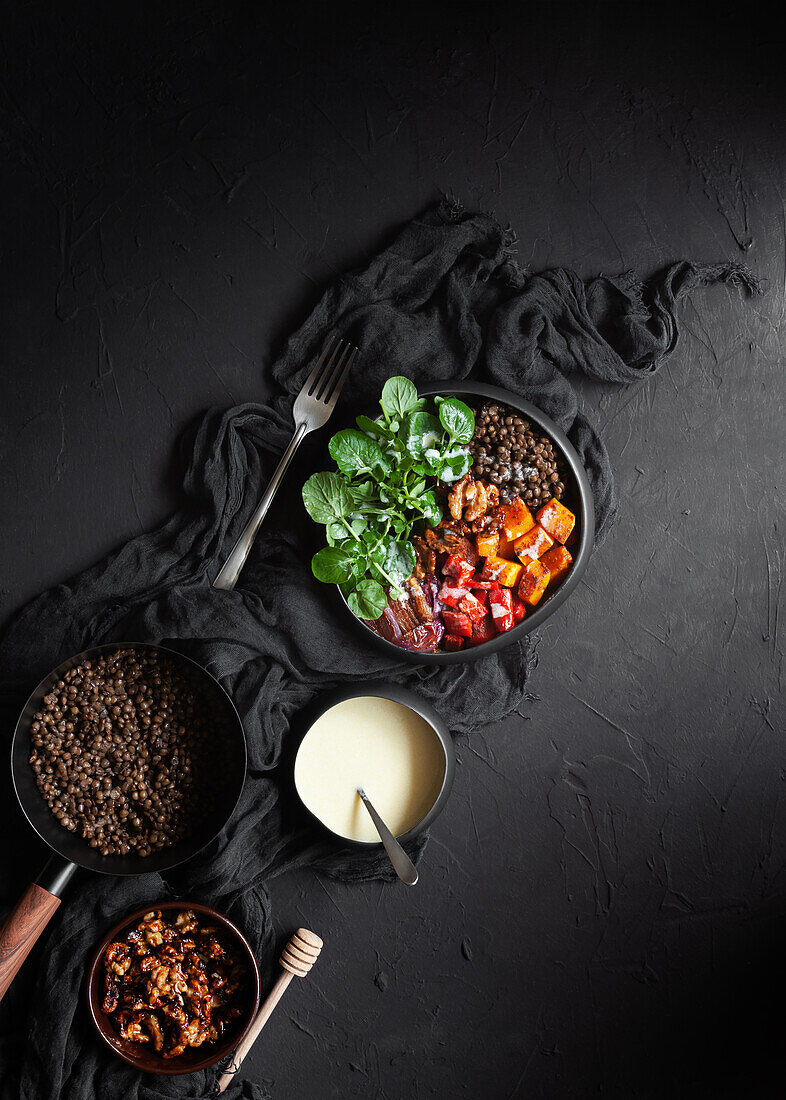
left=213, top=337, right=357, bottom=589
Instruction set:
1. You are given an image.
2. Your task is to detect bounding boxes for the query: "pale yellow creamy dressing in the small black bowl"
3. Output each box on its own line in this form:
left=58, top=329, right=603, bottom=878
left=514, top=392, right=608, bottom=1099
left=295, top=695, right=445, bottom=842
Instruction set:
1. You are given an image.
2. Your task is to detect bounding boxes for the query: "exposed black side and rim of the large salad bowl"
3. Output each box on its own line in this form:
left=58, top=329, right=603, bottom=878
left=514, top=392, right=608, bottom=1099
left=339, top=382, right=595, bottom=664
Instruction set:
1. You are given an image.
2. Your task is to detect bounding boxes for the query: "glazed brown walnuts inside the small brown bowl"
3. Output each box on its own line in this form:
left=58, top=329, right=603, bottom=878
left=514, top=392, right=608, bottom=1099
left=101, top=910, right=245, bottom=1058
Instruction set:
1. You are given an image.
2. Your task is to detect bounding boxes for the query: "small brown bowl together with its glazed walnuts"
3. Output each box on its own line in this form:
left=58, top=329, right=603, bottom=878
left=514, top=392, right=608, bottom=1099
left=87, top=901, right=261, bottom=1076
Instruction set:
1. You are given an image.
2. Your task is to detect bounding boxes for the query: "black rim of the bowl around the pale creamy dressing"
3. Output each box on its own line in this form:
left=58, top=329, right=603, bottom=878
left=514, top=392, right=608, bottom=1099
left=290, top=677, right=456, bottom=849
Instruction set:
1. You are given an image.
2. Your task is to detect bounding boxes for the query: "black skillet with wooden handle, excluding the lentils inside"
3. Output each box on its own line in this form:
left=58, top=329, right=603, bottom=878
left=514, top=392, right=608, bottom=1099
left=0, top=641, right=246, bottom=999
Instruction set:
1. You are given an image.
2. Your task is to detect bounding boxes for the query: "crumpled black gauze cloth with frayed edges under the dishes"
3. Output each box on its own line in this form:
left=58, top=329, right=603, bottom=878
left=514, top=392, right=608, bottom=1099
left=0, top=201, right=755, bottom=1100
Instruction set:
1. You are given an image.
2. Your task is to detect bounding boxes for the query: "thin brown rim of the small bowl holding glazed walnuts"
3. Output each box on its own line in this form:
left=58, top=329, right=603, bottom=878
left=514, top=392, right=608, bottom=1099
left=85, top=898, right=262, bottom=1077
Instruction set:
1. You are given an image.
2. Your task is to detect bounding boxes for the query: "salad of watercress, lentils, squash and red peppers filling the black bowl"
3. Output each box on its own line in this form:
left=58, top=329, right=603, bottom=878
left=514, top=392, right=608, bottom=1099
left=303, top=377, right=576, bottom=653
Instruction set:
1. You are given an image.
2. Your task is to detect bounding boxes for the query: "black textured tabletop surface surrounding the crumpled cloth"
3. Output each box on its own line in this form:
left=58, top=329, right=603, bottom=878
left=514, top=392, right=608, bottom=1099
left=0, top=3, right=786, bottom=1100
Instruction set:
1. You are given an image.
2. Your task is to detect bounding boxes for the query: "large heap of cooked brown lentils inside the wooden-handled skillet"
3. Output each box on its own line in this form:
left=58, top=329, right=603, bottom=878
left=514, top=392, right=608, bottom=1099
left=30, top=649, right=226, bottom=856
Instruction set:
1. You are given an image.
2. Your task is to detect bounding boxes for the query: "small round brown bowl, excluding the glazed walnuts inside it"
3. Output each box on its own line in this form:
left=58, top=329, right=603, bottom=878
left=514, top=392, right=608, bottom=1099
left=87, top=901, right=261, bottom=1077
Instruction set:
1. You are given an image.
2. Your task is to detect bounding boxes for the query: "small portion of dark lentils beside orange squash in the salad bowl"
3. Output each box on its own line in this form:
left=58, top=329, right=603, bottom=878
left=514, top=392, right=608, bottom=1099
left=469, top=402, right=565, bottom=509
